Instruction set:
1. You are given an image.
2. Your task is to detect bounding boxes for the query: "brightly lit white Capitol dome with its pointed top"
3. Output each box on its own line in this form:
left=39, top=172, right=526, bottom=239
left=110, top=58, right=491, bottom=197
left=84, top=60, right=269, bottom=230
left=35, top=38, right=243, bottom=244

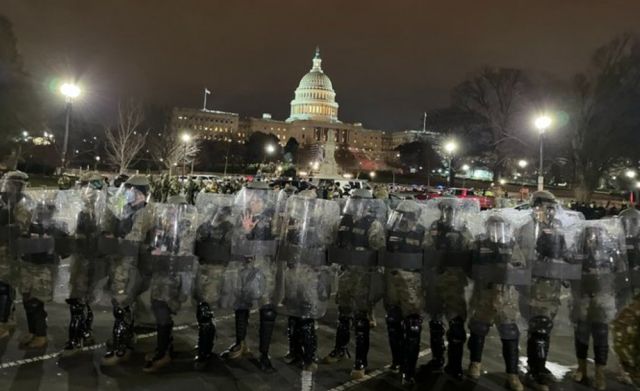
left=287, top=48, right=340, bottom=122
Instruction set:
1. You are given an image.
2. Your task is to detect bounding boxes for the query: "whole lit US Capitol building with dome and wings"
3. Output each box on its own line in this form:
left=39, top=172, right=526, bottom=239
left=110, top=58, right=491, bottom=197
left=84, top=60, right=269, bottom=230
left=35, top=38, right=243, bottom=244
left=172, top=48, right=424, bottom=169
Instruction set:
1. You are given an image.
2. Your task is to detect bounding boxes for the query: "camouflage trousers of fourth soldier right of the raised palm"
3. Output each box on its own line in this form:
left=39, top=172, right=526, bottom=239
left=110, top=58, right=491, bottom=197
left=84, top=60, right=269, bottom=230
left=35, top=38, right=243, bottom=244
left=425, top=268, right=469, bottom=320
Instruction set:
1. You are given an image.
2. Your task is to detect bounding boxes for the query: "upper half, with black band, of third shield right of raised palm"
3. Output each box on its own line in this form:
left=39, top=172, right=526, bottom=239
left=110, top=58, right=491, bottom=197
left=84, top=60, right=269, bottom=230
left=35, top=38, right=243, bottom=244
left=381, top=200, right=429, bottom=271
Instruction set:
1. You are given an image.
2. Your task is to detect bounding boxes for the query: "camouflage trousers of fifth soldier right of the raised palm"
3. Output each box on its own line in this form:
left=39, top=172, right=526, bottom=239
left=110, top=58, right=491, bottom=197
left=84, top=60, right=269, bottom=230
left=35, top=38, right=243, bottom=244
left=469, top=282, right=518, bottom=325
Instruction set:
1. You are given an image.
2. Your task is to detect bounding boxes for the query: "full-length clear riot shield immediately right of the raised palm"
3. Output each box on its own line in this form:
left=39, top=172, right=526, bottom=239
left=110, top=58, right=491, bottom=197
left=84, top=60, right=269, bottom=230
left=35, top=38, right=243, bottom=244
left=278, top=196, right=340, bottom=319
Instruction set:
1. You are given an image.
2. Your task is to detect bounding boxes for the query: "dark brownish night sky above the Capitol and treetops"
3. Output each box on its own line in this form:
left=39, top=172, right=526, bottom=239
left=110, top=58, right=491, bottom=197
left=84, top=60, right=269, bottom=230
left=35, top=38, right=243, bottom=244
left=0, top=0, right=640, bottom=130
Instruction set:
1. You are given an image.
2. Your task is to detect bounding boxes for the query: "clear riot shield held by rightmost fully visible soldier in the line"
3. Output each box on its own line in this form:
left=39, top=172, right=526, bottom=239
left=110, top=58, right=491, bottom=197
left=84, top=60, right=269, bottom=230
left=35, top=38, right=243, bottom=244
left=570, top=218, right=629, bottom=323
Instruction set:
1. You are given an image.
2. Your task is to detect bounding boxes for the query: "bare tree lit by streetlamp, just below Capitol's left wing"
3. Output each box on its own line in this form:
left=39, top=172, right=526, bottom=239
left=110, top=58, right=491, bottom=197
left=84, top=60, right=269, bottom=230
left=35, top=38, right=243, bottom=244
left=149, top=126, right=200, bottom=175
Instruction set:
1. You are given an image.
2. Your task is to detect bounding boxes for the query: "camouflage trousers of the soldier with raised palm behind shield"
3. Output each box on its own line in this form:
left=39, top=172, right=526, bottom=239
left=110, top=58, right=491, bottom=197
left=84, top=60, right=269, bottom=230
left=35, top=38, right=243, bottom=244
left=221, top=257, right=278, bottom=309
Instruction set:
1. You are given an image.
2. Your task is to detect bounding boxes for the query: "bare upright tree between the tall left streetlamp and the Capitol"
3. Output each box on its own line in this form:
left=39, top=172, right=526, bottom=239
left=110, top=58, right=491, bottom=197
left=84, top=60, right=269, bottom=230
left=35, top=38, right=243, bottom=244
left=104, top=101, right=148, bottom=174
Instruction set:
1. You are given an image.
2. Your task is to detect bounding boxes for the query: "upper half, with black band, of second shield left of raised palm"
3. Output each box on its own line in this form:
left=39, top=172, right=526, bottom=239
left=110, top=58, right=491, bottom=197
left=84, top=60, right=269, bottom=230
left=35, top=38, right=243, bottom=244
left=141, top=204, right=198, bottom=275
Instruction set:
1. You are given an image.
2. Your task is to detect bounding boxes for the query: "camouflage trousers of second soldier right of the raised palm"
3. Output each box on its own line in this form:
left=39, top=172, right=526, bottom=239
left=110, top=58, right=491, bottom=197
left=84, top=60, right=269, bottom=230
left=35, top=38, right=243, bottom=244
left=336, top=266, right=384, bottom=316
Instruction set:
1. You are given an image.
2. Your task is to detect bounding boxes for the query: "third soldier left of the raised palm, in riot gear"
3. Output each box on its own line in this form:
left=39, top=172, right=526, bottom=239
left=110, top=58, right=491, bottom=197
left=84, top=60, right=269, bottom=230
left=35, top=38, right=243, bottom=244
left=98, top=175, right=151, bottom=366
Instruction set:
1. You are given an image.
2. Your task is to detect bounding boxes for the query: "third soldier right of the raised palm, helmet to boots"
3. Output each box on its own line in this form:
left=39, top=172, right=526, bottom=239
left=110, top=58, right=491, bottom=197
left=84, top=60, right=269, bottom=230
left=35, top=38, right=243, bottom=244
left=383, top=200, right=428, bottom=384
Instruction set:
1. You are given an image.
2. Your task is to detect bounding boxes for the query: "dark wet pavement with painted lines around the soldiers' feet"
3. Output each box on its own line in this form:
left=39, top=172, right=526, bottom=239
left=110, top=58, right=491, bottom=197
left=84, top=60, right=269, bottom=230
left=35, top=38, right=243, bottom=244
left=0, top=298, right=633, bottom=391
